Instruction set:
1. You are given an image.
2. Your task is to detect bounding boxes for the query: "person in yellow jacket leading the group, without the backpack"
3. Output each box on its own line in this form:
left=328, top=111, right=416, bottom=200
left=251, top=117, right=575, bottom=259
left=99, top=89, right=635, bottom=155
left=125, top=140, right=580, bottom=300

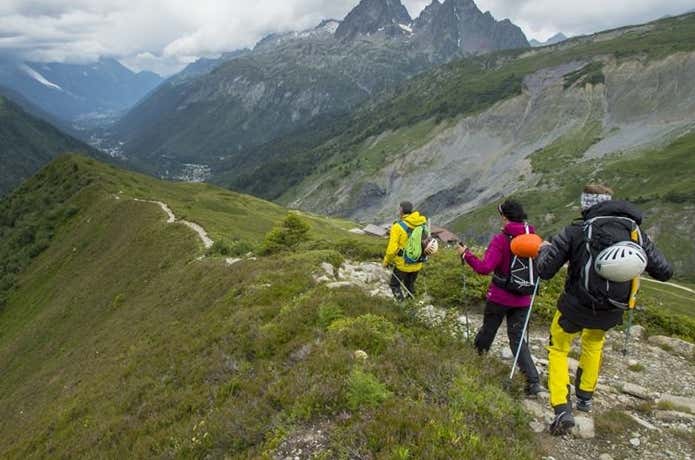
left=383, top=201, right=427, bottom=300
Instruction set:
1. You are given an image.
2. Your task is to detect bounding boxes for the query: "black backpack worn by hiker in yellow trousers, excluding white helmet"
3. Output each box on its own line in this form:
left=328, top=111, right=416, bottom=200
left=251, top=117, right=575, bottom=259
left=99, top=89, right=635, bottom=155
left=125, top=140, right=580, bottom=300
left=579, top=216, right=643, bottom=310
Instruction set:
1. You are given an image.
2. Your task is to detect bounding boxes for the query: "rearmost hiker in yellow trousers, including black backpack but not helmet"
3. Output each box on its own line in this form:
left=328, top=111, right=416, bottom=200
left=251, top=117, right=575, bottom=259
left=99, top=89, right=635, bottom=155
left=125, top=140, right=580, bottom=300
left=537, top=184, right=673, bottom=435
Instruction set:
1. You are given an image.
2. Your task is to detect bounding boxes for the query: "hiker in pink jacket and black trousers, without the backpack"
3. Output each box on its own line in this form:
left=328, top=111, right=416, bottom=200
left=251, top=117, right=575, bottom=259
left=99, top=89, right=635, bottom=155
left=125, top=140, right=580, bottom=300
left=457, top=199, right=541, bottom=396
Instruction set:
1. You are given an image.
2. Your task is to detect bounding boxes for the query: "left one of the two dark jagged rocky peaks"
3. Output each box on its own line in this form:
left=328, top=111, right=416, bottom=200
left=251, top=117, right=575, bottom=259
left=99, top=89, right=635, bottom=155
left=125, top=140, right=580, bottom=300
left=335, top=0, right=412, bottom=39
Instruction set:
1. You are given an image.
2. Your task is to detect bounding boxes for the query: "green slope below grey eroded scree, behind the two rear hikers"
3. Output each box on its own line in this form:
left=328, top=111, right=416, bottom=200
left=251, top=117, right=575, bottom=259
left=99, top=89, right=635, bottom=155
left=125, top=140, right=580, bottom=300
left=451, top=133, right=695, bottom=280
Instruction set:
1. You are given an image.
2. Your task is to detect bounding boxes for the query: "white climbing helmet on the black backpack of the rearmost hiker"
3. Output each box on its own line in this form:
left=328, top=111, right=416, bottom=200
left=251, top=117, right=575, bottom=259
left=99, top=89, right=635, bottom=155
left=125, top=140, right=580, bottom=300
left=594, top=241, right=647, bottom=283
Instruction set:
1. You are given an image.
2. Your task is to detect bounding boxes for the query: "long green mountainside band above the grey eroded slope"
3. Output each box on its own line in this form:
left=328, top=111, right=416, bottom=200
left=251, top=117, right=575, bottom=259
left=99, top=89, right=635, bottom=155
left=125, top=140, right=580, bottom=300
left=231, top=13, right=695, bottom=202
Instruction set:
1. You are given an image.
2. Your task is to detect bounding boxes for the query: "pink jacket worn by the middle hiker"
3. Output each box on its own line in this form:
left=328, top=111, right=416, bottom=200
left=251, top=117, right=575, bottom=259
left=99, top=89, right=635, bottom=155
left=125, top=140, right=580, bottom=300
left=463, top=222, right=535, bottom=308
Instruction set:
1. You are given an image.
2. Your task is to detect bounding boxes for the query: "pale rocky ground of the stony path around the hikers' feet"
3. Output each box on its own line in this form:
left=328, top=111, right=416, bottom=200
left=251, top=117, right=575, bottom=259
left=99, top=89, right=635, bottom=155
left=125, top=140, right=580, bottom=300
left=312, top=262, right=695, bottom=460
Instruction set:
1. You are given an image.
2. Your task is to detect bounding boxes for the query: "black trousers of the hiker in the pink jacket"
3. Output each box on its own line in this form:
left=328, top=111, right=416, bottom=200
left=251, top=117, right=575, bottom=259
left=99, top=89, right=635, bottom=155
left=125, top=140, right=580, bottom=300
left=475, top=301, right=539, bottom=384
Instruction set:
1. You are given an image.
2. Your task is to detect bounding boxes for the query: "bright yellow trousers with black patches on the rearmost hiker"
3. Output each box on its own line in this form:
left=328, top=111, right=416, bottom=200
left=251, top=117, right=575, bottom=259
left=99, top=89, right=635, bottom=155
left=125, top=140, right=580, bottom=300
left=548, top=311, right=606, bottom=407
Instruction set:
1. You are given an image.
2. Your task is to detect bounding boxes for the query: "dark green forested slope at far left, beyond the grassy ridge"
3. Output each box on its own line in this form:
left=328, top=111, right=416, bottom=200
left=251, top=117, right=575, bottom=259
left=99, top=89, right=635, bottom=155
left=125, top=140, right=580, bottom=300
left=0, top=95, right=96, bottom=195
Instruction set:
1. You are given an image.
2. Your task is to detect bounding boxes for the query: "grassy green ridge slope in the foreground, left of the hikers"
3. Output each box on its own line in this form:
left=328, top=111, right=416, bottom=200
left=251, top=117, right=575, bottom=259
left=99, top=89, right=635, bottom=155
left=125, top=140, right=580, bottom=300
left=0, top=156, right=540, bottom=459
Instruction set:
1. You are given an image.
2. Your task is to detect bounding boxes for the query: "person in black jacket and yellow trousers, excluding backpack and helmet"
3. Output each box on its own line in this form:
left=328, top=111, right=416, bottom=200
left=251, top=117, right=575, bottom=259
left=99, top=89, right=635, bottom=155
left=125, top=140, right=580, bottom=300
left=537, top=185, right=673, bottom=434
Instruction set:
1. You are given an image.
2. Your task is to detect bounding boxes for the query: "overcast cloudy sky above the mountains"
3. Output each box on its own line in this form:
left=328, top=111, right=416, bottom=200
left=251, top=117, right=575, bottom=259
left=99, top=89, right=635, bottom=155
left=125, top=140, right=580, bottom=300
left=0, top=0, right=695, bottom=75
